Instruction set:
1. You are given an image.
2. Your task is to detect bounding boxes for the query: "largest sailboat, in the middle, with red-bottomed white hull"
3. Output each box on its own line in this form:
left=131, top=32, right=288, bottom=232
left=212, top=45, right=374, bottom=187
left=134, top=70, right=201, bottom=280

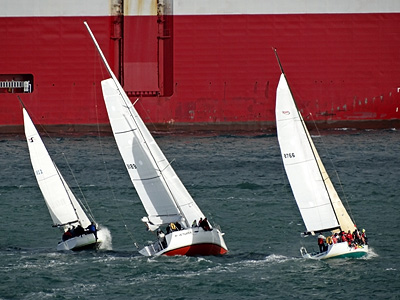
left=84, top=22, right=228, bottom=256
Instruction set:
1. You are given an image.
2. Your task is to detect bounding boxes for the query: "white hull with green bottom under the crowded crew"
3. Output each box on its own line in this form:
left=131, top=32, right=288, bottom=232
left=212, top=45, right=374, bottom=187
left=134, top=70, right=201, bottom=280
left=300, top=242, right=368, bottom=259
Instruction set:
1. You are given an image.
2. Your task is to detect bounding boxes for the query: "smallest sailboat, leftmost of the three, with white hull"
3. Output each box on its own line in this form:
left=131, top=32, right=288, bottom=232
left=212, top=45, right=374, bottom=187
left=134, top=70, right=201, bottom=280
left=20, top=99, right=103, bottom=250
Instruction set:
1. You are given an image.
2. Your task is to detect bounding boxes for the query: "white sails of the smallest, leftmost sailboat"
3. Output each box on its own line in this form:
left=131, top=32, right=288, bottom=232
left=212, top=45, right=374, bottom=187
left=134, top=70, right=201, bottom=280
left=23, top=108, right=90, bottom=228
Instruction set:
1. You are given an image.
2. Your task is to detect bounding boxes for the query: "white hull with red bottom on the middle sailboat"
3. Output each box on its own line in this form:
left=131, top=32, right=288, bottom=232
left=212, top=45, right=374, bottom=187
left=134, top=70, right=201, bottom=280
left=139, top=227, right=228, bottom=256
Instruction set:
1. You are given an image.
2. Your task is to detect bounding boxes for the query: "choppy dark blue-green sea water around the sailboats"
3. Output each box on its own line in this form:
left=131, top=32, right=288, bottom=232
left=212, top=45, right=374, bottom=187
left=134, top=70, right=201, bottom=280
left=0, top=130, right=400, bottom=300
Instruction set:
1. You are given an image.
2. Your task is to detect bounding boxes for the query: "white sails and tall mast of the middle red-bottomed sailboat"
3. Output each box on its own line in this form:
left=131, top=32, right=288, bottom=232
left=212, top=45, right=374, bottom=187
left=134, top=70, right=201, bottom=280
left=85, top=22, right=204, bottom=229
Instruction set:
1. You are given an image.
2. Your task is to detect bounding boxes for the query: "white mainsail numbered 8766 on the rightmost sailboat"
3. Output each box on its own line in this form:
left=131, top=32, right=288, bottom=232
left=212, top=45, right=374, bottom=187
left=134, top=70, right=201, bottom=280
left=276, top=73, right=350, bottom=232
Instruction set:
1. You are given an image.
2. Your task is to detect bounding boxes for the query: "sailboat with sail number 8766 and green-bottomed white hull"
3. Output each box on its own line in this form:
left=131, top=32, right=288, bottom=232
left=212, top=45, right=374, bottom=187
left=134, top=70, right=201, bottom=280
left=274, top=49, right=368, bottom=259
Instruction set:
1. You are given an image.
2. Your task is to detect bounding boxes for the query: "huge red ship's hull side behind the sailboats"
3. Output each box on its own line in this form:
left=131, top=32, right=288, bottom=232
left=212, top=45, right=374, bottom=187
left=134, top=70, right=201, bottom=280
left=0, top=1, right=400, bottom=132
